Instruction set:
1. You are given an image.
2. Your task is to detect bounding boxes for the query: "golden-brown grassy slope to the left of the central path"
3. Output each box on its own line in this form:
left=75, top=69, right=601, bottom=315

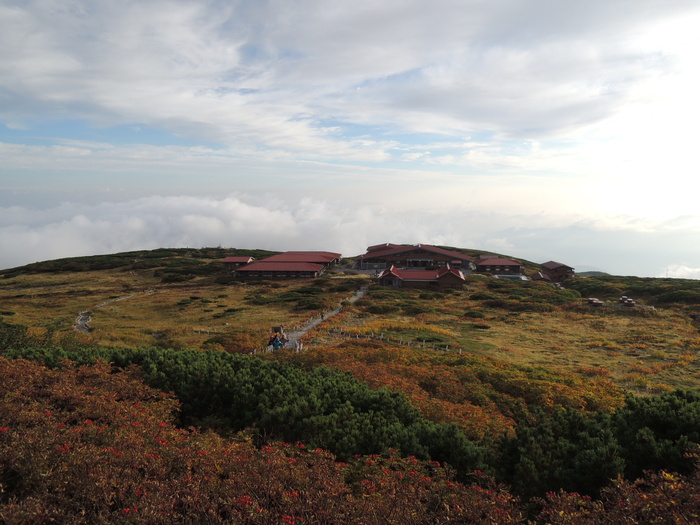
left=0, top=252, right=364, bottom=347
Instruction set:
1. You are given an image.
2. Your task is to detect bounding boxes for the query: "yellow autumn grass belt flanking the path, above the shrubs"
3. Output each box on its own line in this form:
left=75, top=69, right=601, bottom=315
left=0, top=264, right=700, bottom=392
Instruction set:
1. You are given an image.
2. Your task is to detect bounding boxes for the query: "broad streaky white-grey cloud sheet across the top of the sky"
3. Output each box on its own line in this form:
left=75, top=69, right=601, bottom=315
left=0, top=0, right=698, bottom=156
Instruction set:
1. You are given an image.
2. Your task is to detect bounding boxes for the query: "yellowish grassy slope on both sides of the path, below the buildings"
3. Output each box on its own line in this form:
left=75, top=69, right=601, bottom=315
left=0, top=249, right=700, bottom=393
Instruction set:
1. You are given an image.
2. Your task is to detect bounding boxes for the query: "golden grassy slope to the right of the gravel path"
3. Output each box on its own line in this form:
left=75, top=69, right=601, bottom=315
left=304, top=279, right=700, bottom=393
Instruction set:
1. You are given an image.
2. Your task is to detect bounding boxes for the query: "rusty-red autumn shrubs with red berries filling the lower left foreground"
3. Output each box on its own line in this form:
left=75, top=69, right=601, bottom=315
left=0, top=359, right=521, bottom=524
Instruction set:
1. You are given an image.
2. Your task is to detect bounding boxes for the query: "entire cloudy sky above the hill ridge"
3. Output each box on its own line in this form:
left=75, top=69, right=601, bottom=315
left=0, top=0, right=700, bottom=279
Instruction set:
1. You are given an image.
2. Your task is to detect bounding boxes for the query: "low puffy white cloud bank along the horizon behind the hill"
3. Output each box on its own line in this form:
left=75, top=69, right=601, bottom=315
left=0, top=195, right=700, bottom=279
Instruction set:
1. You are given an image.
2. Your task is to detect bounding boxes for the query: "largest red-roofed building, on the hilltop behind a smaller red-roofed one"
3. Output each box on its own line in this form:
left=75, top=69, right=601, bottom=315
left=357, top=243, right=472, bottom=270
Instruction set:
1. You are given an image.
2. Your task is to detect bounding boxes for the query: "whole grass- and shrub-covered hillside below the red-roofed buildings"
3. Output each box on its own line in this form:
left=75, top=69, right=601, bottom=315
left=0, top=247, right=700, bottom=525
